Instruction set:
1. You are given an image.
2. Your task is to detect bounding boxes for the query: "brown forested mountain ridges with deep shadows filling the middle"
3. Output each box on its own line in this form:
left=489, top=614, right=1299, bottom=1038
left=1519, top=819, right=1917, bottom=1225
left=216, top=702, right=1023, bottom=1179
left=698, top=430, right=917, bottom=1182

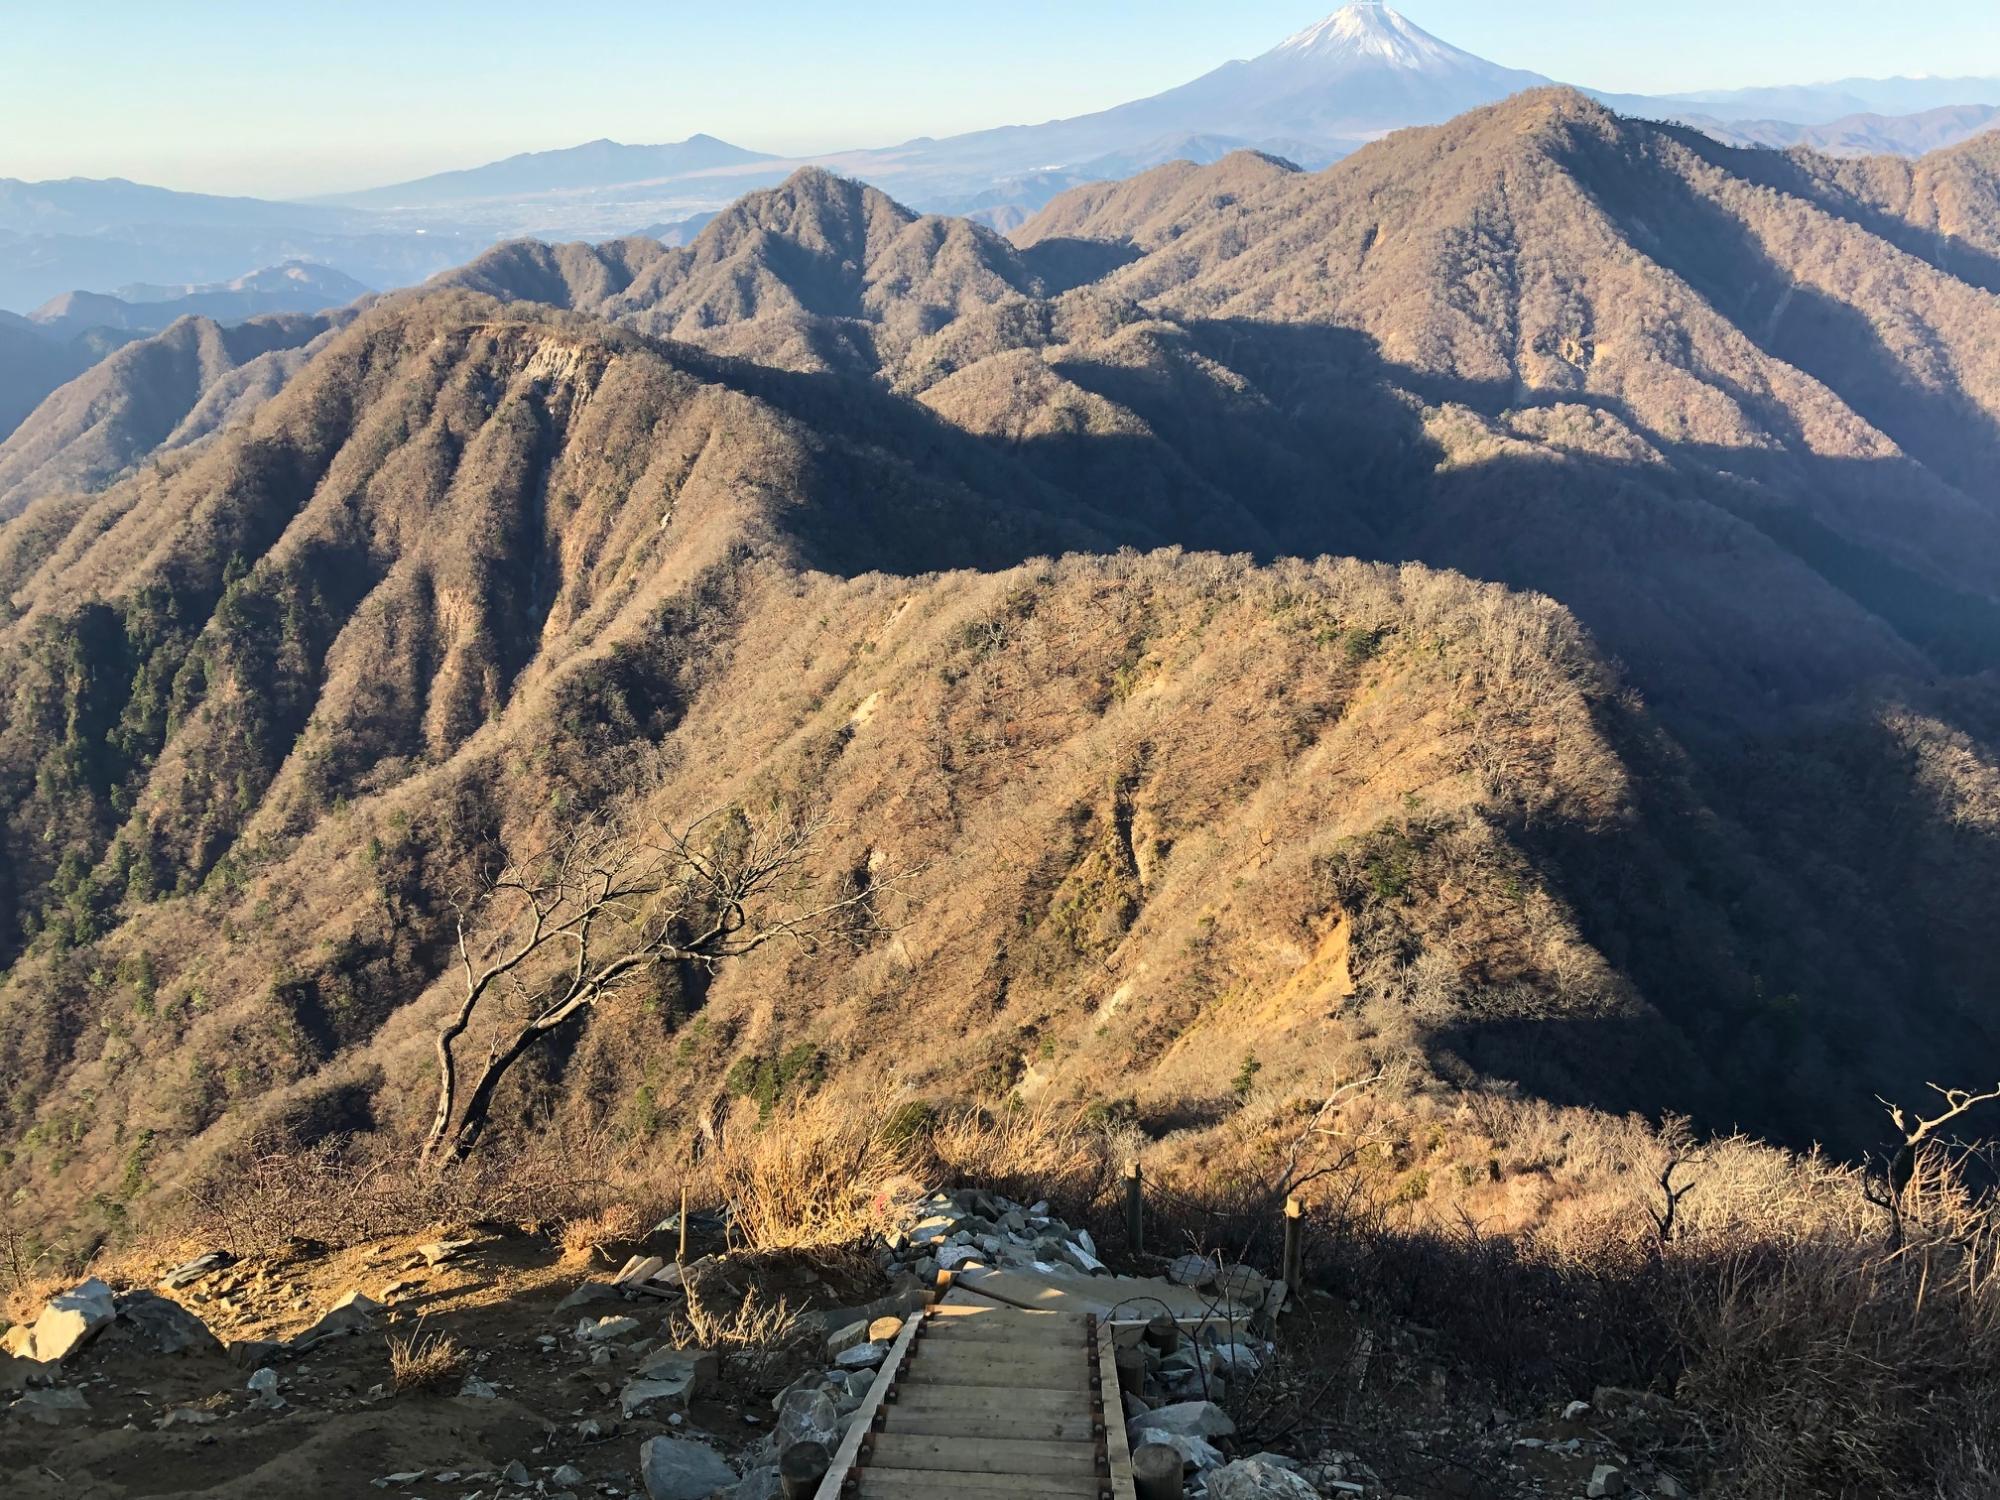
left=0, top=90, right=2000, bottom=1224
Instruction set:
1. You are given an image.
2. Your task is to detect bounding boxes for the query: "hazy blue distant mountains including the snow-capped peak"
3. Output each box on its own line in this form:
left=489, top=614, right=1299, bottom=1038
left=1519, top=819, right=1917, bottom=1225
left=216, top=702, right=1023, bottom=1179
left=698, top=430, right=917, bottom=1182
left=0, top=0, right=2000, bottom=310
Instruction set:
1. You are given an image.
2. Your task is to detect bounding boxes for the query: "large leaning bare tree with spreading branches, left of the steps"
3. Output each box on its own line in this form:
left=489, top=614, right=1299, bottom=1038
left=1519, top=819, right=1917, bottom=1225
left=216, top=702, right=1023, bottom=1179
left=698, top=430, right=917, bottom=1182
left=422, top=810, right=916, bottom=1164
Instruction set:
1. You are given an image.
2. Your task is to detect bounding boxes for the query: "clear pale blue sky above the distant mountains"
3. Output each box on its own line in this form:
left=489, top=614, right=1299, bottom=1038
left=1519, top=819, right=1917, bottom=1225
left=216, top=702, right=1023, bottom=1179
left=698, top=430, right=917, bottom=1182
left=11, top=0, right=2000, bottom=196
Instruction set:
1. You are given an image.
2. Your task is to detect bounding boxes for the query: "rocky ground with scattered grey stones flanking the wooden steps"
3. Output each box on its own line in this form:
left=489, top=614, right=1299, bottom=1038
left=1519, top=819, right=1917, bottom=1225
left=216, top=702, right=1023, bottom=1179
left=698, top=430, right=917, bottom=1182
left=0, top=1192, right=1690, bottom=1500
